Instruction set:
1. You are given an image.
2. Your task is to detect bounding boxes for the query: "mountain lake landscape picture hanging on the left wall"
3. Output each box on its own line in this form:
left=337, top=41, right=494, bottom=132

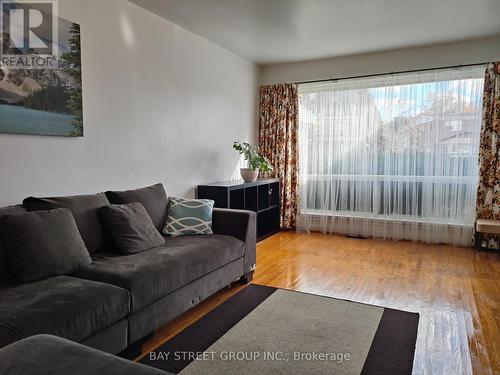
left=0, top=6, right=83, bottom=137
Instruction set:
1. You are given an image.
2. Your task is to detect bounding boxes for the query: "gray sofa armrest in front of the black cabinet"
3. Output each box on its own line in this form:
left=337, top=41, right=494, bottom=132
left=212, top=208, right=257, bottom=274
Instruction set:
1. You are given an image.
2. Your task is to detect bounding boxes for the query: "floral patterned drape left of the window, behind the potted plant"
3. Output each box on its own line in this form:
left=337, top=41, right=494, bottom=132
left=259, top=84, right=299, bottom=229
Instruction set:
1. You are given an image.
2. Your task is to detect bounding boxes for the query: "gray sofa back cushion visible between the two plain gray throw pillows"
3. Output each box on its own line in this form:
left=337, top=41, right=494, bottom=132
left=23, top=193, right=109, bottom=253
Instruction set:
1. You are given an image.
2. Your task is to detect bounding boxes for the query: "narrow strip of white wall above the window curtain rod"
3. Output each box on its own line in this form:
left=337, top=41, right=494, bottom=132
left=261, top=35, right=500, bottom=85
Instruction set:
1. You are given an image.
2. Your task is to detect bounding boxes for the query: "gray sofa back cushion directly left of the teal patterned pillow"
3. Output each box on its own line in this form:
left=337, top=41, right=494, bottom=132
left=106, top=184, right=168, bottom=231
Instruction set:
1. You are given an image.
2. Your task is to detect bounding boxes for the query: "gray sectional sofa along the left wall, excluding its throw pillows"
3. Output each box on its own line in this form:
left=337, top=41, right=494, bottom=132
left=0, top=184, right=256, bottom=355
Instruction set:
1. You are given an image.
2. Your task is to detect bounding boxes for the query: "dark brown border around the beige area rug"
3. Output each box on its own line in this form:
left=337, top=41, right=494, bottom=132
left=139, top=284, right=420, bottom=375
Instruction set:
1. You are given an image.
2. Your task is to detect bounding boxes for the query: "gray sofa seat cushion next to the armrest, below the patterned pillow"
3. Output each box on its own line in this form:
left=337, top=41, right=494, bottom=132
left=74, top=235, right=245, bottom=312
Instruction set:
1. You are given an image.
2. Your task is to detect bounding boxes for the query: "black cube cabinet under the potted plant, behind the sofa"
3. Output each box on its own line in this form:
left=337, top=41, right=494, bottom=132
left=197, top=178, right=281, bottom=241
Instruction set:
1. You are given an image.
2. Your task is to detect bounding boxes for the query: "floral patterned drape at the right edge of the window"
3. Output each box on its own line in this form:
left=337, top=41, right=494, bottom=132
left=477, top=62, right=500, bottom=249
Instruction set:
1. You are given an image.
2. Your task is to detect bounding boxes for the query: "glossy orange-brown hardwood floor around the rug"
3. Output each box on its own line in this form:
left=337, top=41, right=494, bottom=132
left=138, top=232, right=500, bottom=375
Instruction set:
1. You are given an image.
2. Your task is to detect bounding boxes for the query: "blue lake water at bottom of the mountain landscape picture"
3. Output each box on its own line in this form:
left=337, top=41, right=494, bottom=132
left=0, top=104, right=75, bottom=136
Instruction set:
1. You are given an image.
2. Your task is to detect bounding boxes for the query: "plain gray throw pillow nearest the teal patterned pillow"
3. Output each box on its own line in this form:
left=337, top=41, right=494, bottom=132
left=99, top=202, right=165, bottom=254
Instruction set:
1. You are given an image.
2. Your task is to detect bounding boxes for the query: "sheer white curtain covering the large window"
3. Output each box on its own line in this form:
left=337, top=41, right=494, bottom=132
left=297, top=67, right=484, bottom=246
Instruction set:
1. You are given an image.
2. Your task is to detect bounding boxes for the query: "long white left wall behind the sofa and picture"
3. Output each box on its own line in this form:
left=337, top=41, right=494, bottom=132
left=0, top=0, right=259, bottom=205
